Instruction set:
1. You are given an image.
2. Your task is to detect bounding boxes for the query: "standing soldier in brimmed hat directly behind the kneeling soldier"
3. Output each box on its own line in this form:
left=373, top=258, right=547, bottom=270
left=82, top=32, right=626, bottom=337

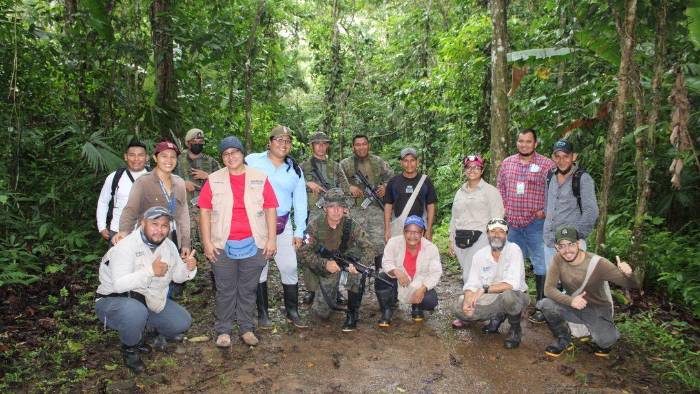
left=301, top=132, right=350, bottom=304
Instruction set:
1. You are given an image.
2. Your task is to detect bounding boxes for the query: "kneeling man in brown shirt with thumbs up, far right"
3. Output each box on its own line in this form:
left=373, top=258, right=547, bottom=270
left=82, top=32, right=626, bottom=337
left=537, top=226, right=639, bottom=357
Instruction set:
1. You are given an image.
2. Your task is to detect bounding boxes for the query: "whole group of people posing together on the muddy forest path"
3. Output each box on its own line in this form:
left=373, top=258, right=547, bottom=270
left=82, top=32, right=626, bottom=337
left=96, top=126, right=638, bottom=372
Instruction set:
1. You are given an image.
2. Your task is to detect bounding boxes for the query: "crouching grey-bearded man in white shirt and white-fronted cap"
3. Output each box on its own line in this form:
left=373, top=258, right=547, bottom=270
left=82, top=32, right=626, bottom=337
left=455, top=218, right=530, bottom=349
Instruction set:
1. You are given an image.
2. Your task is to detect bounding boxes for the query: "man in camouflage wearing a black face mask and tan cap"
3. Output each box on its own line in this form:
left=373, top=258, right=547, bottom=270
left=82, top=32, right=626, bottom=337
left=174, top=129, right=221, bottom=249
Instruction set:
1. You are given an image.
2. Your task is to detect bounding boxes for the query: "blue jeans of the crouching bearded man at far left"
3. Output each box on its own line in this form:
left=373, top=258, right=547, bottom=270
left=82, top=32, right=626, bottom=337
left=95, top=297, right=192, bottom=346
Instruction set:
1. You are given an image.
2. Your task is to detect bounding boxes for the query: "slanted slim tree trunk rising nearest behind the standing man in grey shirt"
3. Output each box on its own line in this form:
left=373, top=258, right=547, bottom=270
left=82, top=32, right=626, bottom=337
left=596, top=0, right=637, bottom=248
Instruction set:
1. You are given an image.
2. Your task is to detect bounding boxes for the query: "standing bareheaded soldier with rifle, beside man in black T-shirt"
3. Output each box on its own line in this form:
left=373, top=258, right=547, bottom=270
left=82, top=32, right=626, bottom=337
left=340, top=134, right=394, bottom=267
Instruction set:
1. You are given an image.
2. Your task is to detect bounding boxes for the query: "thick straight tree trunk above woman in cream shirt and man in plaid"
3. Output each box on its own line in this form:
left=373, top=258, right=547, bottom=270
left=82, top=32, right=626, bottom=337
left=489, top=0, right=508, bottom=184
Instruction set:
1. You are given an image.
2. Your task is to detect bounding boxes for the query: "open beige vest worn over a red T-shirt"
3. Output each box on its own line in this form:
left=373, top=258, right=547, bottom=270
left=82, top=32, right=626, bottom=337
left=209, top=166, right=267, bottom=249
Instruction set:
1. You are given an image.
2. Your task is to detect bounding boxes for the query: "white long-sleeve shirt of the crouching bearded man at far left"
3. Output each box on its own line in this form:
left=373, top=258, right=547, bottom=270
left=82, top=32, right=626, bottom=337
left=97, top=227, right=197, bottom=313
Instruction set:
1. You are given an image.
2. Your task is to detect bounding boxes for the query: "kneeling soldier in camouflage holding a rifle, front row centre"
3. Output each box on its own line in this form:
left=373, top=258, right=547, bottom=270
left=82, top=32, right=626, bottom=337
left=299, top=188, right=374, bottom=332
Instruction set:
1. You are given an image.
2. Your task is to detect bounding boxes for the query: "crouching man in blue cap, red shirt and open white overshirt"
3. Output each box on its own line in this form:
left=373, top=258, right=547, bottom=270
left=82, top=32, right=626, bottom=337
left=374, top=215, right=442, bottom=328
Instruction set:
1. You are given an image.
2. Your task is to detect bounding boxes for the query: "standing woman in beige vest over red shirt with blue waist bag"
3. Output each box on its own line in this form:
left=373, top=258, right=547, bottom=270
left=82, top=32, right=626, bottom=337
left=198, top=136, right=278, bottom=347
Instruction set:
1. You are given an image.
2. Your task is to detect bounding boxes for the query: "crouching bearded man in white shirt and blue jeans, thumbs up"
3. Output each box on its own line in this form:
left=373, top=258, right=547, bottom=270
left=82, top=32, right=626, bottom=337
left=95, top=207, right=197, bottom=373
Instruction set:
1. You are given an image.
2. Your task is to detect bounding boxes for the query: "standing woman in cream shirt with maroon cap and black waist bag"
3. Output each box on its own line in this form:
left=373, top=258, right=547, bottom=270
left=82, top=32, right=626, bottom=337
left=449, top=155, right=504, bottom=328
